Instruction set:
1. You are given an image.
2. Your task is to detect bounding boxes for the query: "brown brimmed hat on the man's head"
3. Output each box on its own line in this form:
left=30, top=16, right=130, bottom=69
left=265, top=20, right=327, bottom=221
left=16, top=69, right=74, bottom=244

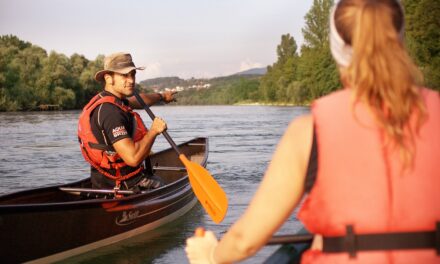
left=95, top=52, right=145, bottom=82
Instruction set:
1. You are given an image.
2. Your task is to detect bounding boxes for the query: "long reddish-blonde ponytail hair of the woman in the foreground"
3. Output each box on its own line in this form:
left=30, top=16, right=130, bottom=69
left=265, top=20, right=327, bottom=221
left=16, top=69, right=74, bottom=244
left=334, top=0, right=426, bottom=168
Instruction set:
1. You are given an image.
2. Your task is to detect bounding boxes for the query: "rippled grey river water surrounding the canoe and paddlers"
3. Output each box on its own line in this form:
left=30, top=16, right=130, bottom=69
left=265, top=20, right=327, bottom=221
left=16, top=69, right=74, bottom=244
left=0, top=106, right=309, bottom=264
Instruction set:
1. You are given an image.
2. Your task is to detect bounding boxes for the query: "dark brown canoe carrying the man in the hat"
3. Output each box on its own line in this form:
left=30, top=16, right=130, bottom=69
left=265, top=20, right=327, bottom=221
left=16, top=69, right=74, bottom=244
left=0, top=138, right=208, bottom=263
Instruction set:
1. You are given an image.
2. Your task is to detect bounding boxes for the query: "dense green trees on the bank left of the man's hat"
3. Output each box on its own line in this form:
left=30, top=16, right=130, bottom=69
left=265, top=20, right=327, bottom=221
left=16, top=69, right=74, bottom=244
left=0, top=35, right=104, bottom=111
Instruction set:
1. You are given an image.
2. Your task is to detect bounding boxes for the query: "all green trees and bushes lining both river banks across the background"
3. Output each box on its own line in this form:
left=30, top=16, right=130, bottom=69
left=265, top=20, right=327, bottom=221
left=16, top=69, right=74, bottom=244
left=0, top=0, right=440, bottom=111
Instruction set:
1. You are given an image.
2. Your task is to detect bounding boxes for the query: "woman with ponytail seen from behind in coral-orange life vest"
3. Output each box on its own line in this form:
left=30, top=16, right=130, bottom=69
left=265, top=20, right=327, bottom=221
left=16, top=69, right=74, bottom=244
left=186, top=0, right=440, bottom=264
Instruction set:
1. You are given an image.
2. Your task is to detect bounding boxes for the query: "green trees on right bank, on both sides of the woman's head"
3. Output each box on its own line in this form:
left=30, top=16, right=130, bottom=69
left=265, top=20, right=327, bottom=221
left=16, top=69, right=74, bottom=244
left=177, top=0, right=440, bottom=105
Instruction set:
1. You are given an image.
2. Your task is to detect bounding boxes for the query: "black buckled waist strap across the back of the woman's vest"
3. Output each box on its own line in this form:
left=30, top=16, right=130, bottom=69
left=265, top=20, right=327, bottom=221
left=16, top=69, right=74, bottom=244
left=322, top=222, right=440, bottom=258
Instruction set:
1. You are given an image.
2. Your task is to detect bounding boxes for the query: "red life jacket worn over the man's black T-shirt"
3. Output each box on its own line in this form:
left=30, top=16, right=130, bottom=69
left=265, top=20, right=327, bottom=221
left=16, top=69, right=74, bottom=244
left=78, top=94, right=148, bottom=185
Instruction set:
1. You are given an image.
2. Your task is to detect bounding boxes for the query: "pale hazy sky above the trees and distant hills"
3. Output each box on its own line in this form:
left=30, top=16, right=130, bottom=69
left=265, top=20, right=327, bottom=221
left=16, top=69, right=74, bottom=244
left=0, top=0, right=313, bottom=80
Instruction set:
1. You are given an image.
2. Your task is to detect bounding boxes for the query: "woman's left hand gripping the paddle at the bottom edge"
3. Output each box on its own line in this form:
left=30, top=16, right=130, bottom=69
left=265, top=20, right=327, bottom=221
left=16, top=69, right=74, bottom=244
left=185, top=231, right=218, bottom=264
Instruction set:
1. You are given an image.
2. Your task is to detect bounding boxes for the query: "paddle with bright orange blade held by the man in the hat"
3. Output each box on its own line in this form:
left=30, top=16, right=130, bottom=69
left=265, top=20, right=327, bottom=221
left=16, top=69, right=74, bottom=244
left=133, top=90, right=228, bottom=224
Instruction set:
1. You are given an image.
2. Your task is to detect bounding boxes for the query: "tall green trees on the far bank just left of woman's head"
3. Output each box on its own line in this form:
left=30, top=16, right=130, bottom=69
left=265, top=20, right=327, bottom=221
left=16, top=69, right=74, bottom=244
left=259, top=0, right=341, bottom=104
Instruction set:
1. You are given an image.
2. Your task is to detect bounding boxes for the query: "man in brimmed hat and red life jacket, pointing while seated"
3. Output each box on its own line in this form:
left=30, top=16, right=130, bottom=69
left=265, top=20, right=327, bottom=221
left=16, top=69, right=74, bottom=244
left=78, top=52, right=175, bottom=191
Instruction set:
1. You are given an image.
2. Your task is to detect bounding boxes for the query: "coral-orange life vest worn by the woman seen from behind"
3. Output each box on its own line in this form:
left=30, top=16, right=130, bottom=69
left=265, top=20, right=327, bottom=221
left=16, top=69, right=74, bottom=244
left=298, top=88, right=440, bottom=263
